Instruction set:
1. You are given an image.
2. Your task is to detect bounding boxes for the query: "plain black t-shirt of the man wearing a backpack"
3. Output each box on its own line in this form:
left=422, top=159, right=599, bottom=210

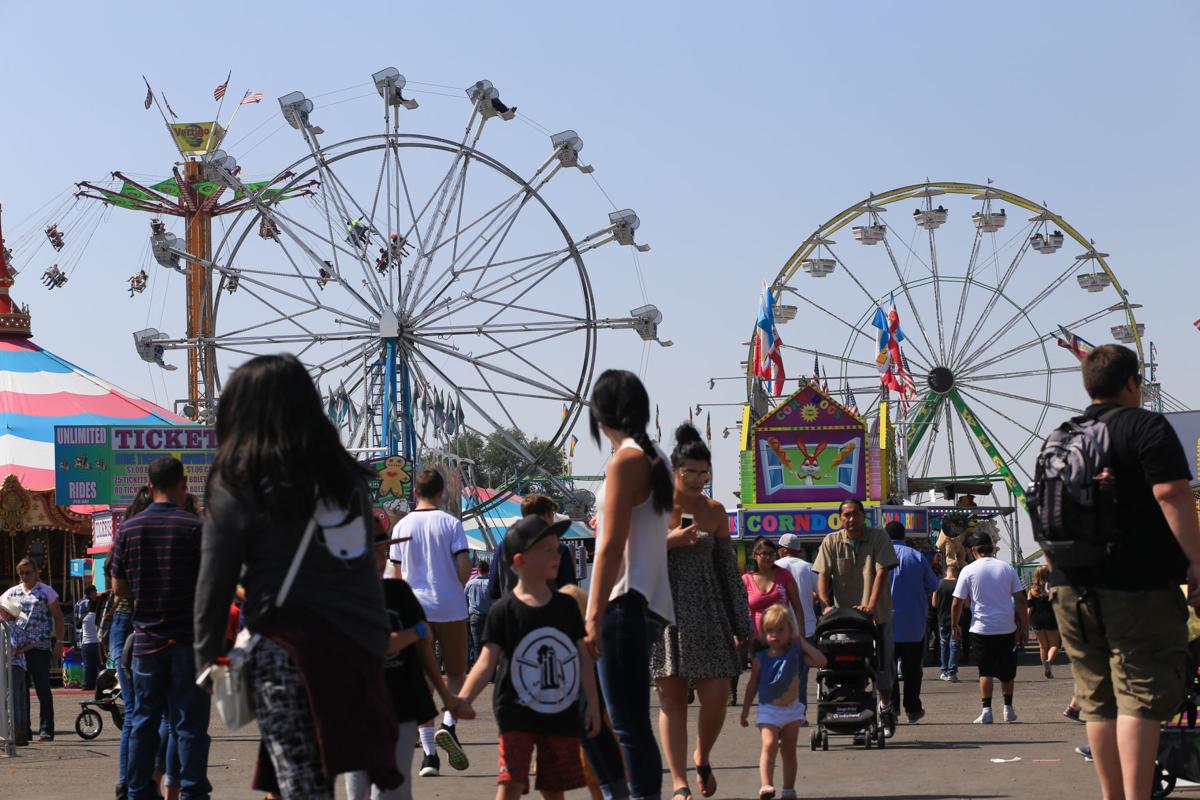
left=1073, top=404, right=1192, bottom=591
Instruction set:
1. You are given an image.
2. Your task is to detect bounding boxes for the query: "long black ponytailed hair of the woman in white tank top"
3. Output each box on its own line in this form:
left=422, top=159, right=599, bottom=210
left=588, top=369, right=674, bottom=513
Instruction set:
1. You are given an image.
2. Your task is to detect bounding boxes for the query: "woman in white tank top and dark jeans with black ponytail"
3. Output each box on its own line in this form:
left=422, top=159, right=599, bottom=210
left=586, top=369, right=674, bottom=799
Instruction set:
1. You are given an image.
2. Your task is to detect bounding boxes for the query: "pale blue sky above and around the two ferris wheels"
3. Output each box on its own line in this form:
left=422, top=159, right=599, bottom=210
left=0, top=1, right=1200, bottom=520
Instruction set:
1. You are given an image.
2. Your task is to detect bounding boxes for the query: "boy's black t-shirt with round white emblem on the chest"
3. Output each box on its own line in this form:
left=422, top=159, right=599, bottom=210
left=484, top=591, right=584, bottom=736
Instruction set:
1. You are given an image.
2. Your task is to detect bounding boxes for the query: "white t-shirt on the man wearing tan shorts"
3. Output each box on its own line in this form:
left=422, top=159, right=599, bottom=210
left=391, top=510, right=469, bottom=622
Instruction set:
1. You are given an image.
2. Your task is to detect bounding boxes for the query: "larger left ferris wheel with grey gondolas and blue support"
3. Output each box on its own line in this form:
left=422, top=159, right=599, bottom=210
left=139, top=68, right=670, bottom=516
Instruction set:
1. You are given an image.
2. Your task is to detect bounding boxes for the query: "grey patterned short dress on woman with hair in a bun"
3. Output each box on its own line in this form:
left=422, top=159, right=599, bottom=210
left=650, top=531, right=752, bottom=680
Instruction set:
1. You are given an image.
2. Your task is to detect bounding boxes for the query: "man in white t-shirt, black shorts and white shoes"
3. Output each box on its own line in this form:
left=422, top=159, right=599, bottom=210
left=950, top=534, right=1030, bottom=724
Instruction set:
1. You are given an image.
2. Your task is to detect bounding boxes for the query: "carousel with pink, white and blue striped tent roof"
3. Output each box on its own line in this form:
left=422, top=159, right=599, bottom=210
left=0, top=205, right=185, bottom=600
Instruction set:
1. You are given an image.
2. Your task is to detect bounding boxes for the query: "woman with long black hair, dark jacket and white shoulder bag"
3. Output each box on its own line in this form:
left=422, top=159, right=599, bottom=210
left=196, top=355, right=401, bottom=799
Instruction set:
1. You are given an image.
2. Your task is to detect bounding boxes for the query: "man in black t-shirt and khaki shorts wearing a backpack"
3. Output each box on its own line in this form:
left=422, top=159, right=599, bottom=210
left=1030, top=344, right=1200, bottom=800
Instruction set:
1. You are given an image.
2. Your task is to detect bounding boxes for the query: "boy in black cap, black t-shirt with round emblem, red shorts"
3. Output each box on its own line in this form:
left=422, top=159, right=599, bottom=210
left=458, top=515, right=600, bottom=800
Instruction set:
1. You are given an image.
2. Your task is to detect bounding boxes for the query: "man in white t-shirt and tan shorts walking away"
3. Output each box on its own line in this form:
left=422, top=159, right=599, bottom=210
left=391, top=469, right=470, bottom=777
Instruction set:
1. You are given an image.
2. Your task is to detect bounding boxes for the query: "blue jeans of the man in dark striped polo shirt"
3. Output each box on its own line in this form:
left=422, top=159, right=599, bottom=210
left=126, top=643, right=212, bottom=800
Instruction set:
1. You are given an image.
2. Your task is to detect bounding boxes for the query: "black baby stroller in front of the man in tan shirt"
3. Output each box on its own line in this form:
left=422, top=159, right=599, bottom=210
left=811, top=608, right=886, bottom=750
